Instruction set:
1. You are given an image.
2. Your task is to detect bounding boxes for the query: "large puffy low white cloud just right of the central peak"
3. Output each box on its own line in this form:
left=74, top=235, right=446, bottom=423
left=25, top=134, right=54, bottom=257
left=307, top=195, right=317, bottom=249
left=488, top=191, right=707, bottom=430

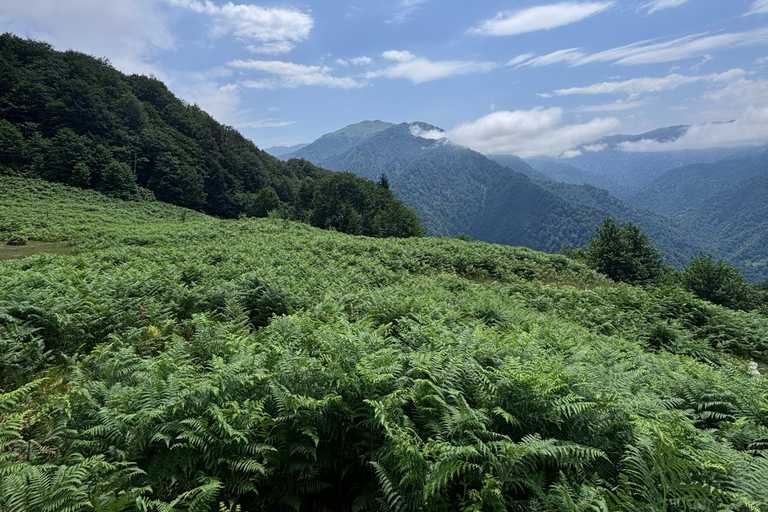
left=440, top=108, right=620, bottom=158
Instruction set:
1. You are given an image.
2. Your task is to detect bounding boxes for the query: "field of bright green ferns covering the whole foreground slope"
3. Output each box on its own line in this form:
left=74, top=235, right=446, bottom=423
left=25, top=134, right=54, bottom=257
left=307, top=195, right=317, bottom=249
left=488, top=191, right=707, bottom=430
left=0, top=178, right=768, bottom=512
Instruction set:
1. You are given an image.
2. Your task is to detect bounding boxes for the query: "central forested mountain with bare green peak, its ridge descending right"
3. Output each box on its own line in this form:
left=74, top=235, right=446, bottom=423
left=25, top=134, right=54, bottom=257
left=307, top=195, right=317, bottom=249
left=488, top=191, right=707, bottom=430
left=286, top=123, right=699, bottom=260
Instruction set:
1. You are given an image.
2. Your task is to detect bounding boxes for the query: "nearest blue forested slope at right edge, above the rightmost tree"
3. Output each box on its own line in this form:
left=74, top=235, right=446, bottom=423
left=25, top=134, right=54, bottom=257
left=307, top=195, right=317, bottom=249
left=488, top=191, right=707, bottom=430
left=680, top=172, right=768, bottom=282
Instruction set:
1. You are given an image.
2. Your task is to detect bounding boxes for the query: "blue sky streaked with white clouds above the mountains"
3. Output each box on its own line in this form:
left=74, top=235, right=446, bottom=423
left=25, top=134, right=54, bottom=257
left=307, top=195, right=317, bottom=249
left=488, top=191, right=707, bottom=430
left=0, top=0, right=768, bottom=158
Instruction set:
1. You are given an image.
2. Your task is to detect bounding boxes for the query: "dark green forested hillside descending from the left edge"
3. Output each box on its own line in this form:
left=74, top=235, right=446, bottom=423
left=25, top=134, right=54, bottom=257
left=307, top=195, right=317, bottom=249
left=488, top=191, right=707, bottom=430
left=0, top=34, right=421, bottom=236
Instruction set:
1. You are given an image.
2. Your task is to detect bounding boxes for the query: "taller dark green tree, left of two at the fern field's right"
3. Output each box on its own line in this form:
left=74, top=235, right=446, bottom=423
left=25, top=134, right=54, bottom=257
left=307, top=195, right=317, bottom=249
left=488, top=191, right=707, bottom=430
left=586, top=217, right=664, bottom=285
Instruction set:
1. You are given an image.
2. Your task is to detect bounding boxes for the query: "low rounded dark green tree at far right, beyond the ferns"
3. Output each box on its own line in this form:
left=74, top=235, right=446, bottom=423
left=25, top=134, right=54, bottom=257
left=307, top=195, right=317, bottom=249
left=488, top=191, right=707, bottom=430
left=683, top=254, right=757, bottom=310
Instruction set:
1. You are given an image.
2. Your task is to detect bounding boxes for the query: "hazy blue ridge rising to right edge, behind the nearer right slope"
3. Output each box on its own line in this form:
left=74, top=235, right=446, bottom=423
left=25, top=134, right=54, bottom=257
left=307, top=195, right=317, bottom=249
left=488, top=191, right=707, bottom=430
left=627, top=152, right=768, bottom=214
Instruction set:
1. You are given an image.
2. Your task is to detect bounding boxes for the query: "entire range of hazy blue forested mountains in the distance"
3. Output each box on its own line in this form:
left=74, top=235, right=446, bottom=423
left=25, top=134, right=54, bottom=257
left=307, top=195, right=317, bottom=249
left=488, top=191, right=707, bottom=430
left=268, top=121, right=768, bottom=281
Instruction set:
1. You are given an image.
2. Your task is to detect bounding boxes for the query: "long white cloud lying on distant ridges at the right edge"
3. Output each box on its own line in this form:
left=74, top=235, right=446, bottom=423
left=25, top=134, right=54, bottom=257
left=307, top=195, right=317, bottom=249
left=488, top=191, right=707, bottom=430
left=619, top=107, right=768, bottom=152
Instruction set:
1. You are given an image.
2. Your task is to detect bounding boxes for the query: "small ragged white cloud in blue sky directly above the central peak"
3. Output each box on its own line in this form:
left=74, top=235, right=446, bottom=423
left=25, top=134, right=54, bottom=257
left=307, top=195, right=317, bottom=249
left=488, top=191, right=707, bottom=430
left=366, top=50, right=499, bottom=84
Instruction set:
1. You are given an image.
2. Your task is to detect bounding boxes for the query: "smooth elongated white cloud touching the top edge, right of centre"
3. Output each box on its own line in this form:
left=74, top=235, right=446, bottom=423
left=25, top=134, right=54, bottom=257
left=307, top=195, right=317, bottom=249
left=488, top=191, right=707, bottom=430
left=471, top=1, right=614, bottom=36
